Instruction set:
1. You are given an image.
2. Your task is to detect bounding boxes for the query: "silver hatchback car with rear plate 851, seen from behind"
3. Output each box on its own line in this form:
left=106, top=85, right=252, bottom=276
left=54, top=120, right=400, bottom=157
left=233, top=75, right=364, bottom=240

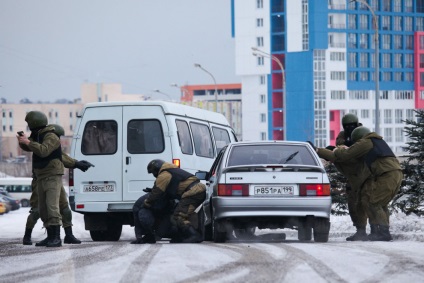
left=196, top=141, right=331, bottom=242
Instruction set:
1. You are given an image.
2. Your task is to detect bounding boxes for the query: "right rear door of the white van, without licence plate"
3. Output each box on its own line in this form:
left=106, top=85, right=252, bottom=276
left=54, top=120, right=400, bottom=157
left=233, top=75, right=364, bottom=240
left=122, top=105, right=173, bottom=201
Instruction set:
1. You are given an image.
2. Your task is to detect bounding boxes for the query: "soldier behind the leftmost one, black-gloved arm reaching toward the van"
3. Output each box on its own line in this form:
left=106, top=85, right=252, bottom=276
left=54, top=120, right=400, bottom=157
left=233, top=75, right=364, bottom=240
left=22, top=124, right=93, bottom=246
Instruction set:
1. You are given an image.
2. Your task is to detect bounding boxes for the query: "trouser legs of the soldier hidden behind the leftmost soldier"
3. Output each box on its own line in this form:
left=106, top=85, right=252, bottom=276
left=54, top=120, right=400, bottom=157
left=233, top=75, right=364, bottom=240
left=26, top=182, right=72, bottom=229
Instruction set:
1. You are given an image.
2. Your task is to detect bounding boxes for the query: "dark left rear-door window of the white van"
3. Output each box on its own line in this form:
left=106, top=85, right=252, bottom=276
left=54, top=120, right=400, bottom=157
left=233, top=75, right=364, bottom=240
left=81, top=120, right=118, bottom=155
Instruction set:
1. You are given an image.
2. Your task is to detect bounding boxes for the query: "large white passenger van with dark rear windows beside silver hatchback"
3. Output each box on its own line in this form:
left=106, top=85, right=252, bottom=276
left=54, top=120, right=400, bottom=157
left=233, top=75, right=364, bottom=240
left=69, top=101, right=237, bottom=241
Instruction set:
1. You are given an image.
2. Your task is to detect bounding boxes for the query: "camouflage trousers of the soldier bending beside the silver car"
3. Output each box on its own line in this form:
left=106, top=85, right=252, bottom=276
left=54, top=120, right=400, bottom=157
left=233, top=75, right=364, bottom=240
left=172, top=183, right=206, bottom=229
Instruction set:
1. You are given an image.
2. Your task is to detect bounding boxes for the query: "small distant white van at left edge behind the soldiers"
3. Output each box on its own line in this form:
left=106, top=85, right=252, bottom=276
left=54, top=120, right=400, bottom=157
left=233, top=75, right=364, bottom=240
left=0, top=177, right=32, bottom=207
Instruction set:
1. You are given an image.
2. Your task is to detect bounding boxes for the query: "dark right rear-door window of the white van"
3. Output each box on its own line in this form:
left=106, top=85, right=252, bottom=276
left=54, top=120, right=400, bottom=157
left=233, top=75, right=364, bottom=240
left=127, top=120, right=165, bottom=154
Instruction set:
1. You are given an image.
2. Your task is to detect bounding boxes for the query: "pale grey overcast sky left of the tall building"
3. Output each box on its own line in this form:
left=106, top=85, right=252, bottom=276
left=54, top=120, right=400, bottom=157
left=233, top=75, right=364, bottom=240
left=0, top=0, right=240, bottom=103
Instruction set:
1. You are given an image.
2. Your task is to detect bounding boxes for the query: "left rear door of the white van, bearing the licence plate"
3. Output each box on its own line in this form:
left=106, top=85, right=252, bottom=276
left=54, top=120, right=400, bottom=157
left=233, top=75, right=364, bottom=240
left=71, top=106, right=123, bottom=203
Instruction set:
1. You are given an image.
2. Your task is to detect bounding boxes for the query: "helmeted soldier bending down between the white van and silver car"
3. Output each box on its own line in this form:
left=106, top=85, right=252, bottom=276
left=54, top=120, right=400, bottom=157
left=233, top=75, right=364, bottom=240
left=144, top=159, right=206, bottom=243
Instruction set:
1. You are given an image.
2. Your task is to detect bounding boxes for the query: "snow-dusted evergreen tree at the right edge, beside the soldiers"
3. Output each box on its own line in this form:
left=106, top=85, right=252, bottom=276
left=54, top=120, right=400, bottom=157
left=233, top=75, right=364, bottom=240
left=392, top=110, right=424, bottom=216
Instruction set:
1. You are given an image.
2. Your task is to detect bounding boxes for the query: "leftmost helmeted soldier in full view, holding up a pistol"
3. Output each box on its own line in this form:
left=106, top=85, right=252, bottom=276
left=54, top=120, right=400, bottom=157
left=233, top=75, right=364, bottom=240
left=17, top=111, right=64, bottom=247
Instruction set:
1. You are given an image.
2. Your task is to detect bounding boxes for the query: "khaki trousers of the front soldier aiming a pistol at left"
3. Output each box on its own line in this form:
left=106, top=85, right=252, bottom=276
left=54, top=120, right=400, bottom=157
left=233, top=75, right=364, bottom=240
left=36, top=175, right=62, bottom=228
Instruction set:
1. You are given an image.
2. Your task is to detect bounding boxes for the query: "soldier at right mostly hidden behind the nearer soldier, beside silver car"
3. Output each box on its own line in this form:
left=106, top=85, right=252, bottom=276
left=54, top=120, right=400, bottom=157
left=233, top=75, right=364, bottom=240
left=317, top=113, right=370, bottom=241
